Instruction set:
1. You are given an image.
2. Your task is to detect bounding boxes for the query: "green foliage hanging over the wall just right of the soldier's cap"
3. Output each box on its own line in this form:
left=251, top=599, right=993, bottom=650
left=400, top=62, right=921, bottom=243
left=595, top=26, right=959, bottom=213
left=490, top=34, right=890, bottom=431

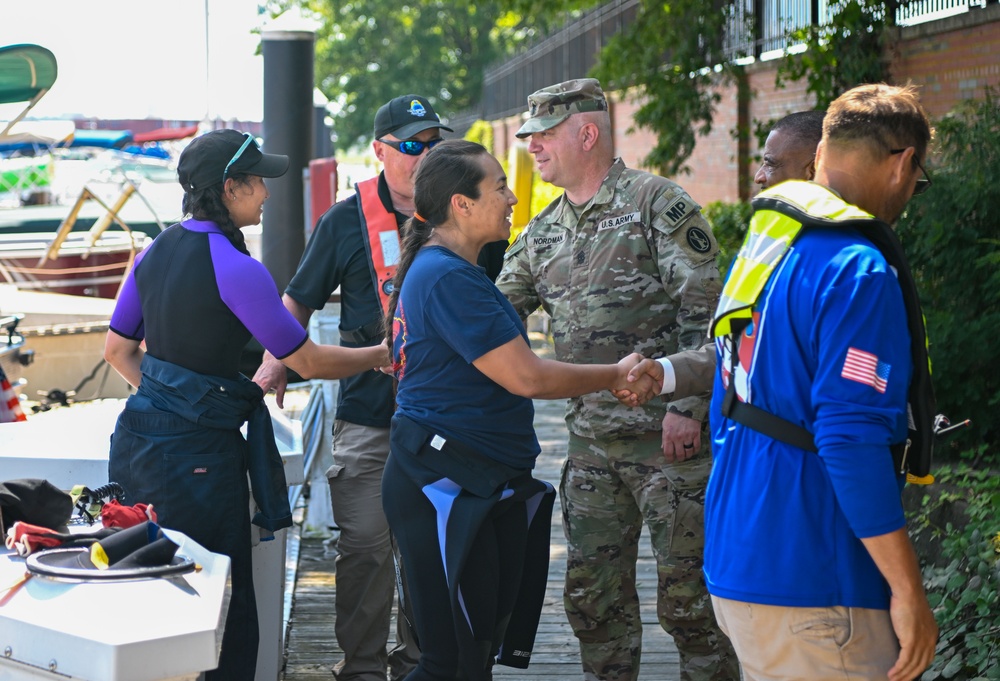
left=593, top=0, right=741, bottom=176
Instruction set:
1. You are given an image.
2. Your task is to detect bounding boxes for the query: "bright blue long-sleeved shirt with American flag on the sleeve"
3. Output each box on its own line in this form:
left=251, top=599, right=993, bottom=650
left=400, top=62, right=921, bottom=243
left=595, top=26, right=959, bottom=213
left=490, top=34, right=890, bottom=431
left=705, top=228, right=911, bottom=609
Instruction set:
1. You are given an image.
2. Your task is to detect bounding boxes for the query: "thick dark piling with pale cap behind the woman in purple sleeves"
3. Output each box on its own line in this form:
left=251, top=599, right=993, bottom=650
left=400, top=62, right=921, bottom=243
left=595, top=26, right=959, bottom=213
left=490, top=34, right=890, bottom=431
left=261, top=28, right=315, bottom=291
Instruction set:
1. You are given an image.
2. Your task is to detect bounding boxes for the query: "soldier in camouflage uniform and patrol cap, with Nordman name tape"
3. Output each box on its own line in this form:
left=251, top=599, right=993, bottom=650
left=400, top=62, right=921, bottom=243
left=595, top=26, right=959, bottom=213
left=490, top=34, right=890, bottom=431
left=497, top=78, right=739, bottom=681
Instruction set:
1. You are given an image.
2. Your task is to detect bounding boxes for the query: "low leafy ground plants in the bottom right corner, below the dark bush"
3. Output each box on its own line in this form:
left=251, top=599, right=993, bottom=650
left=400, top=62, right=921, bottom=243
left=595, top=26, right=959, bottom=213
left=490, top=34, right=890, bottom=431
left=910, top=447, right=1000, bottom=681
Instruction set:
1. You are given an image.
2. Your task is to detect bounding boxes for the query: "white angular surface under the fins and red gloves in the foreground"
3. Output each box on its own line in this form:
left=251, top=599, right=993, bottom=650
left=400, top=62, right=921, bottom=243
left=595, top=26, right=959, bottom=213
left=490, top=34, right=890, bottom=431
left=0, top=530, right=229, bottom=681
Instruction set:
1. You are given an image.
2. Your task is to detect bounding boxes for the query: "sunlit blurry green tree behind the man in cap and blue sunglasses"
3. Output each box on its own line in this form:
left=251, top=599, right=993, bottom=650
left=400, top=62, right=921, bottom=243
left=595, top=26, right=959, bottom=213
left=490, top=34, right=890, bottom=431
left=271, top=0, right=534, bottom=149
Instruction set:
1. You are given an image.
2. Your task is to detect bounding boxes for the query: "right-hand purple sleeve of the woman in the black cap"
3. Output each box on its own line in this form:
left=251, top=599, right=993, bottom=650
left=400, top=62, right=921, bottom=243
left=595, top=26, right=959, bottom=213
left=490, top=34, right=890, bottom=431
left=209, top=234, right=308, bottom=359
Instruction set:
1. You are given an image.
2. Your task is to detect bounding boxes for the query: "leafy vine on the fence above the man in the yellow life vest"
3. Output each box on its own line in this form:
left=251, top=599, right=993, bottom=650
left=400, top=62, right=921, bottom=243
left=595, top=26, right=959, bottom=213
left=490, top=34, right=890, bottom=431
left=775, top=0, right=899, bottom=110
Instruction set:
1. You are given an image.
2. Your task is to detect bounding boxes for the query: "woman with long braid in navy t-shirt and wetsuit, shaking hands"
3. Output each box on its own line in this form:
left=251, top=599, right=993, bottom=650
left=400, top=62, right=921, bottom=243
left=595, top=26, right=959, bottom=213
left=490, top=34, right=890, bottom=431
left=382, top=140, right=658, bottom=681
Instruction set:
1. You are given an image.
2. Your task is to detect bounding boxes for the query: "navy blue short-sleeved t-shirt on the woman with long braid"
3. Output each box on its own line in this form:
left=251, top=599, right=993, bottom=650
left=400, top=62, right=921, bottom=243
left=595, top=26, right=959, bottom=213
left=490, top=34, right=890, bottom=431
left=393, top=246, right=540, bottom=468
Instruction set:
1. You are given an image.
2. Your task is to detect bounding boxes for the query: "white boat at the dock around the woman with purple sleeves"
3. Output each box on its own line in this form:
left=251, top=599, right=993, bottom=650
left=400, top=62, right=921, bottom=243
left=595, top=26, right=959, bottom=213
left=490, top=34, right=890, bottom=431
left=0, top=388, right=304, bottom=681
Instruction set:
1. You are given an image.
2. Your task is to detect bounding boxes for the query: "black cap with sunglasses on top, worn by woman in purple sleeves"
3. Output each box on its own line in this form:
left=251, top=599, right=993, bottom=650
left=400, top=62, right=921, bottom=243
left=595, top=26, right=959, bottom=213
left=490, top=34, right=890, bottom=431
left=177, top=129, right=288, bottom=191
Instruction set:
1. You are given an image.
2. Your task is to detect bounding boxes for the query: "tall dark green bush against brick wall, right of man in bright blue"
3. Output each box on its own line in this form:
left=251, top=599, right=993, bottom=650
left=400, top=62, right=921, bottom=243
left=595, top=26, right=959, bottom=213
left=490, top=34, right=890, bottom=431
left=897, top=92, right=1000, bottom=452
